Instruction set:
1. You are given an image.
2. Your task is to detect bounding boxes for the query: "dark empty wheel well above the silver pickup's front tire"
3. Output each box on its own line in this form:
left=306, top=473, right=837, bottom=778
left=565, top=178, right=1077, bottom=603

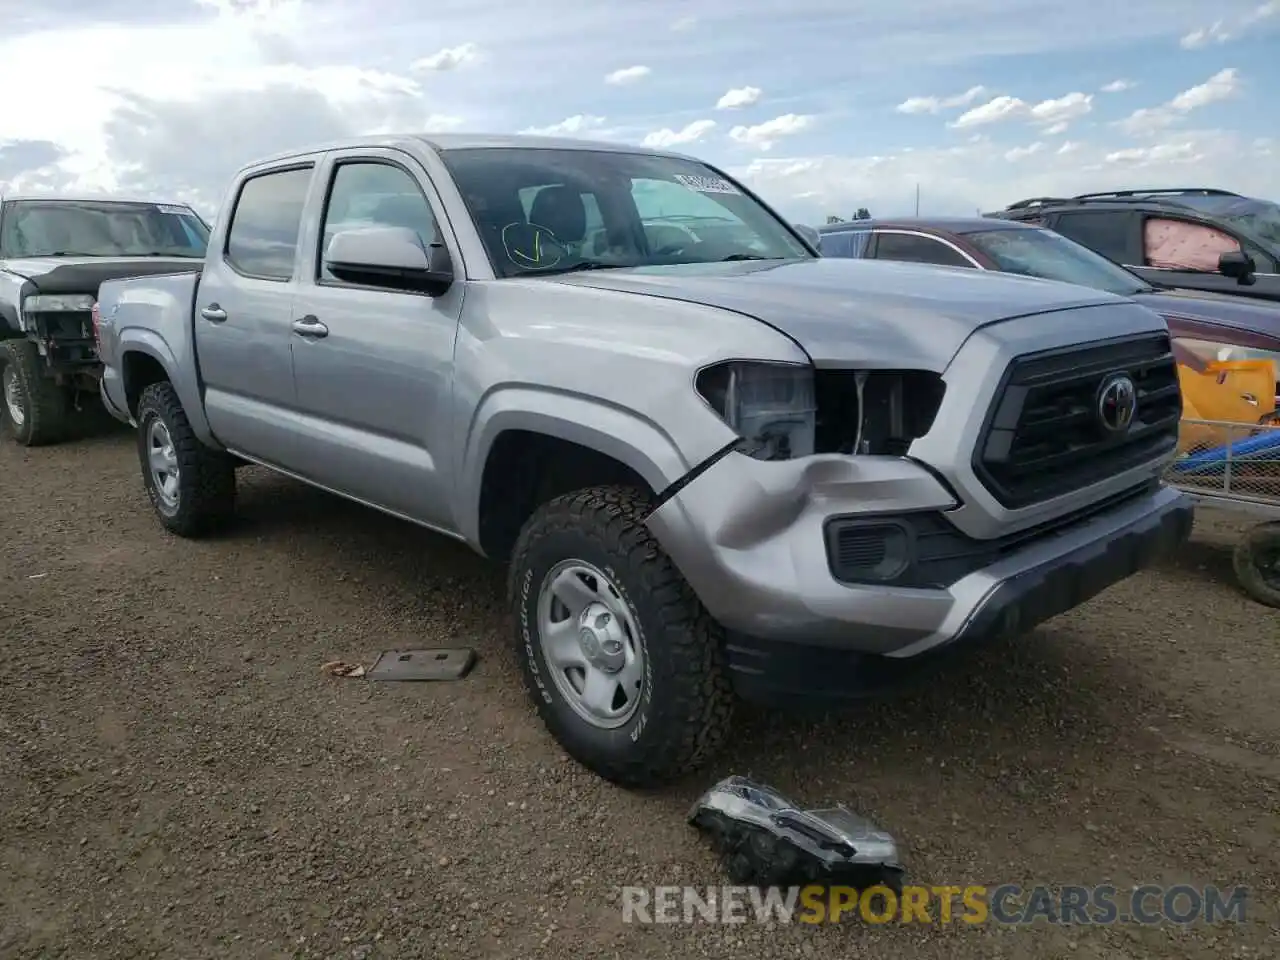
left=480, top=430, right=654, bottom=563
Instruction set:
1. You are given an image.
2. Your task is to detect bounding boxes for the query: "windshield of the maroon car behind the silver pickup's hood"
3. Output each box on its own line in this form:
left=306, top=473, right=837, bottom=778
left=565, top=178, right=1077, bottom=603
left=965, top=228, right=1151, bottom=297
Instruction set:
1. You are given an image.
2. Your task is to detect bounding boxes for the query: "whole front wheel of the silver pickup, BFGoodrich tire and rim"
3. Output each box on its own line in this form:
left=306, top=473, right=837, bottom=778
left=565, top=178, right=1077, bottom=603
left=508, top=486, right=733, bottom=787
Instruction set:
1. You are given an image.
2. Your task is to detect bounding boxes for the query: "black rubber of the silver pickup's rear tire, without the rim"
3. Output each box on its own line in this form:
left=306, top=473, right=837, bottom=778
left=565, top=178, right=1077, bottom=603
left=137, top=380, right=236, bottom=538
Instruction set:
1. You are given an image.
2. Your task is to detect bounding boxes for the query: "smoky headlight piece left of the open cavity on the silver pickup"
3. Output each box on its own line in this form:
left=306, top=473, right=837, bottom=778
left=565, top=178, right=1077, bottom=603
left=695, top=361, right=817, bottom=460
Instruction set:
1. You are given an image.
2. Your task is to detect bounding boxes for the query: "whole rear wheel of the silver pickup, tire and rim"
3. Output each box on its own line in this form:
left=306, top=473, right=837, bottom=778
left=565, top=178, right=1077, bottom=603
left=137, top=383, right=236, bottom=538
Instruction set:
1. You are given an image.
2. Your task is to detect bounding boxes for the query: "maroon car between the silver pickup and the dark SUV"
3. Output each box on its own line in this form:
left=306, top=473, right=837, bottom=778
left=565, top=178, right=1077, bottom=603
left=818, top=218, right=1280, bottom=384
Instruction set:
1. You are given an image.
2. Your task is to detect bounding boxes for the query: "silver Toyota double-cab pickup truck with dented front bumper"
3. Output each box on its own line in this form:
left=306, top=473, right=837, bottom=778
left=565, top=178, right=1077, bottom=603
left=99, top=129, right=1192, bottom=786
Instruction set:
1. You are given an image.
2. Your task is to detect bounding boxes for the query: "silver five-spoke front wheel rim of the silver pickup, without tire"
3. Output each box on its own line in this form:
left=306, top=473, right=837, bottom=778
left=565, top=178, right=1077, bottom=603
left=538, top=559, right=645, bottom=730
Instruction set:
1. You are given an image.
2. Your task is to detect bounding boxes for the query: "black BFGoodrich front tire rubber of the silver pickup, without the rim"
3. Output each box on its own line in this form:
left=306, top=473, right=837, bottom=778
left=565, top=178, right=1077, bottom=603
left=508, top=486, right=733, bottom=787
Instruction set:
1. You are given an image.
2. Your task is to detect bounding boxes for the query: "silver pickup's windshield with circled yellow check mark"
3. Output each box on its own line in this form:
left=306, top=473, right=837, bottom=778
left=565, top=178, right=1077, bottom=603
left=442, top=147, right=813, bottom=276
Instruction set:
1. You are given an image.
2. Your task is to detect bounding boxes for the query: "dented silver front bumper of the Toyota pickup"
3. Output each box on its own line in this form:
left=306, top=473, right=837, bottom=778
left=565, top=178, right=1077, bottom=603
left=648, top=453, right=1193, bottom=691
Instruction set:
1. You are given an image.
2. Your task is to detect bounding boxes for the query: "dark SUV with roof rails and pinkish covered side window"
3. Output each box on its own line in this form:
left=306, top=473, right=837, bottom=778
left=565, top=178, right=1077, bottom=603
left=986, top=188, right=1280, bottom=301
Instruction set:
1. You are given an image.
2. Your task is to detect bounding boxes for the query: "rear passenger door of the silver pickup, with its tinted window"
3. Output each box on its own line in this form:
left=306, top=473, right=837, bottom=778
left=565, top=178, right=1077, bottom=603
left=195, top=163, right=315, bottom=466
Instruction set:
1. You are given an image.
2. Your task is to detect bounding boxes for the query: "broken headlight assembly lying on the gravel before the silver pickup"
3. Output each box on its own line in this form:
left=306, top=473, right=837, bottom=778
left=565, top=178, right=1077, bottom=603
left=689, top=776, right=904, bottom=892
